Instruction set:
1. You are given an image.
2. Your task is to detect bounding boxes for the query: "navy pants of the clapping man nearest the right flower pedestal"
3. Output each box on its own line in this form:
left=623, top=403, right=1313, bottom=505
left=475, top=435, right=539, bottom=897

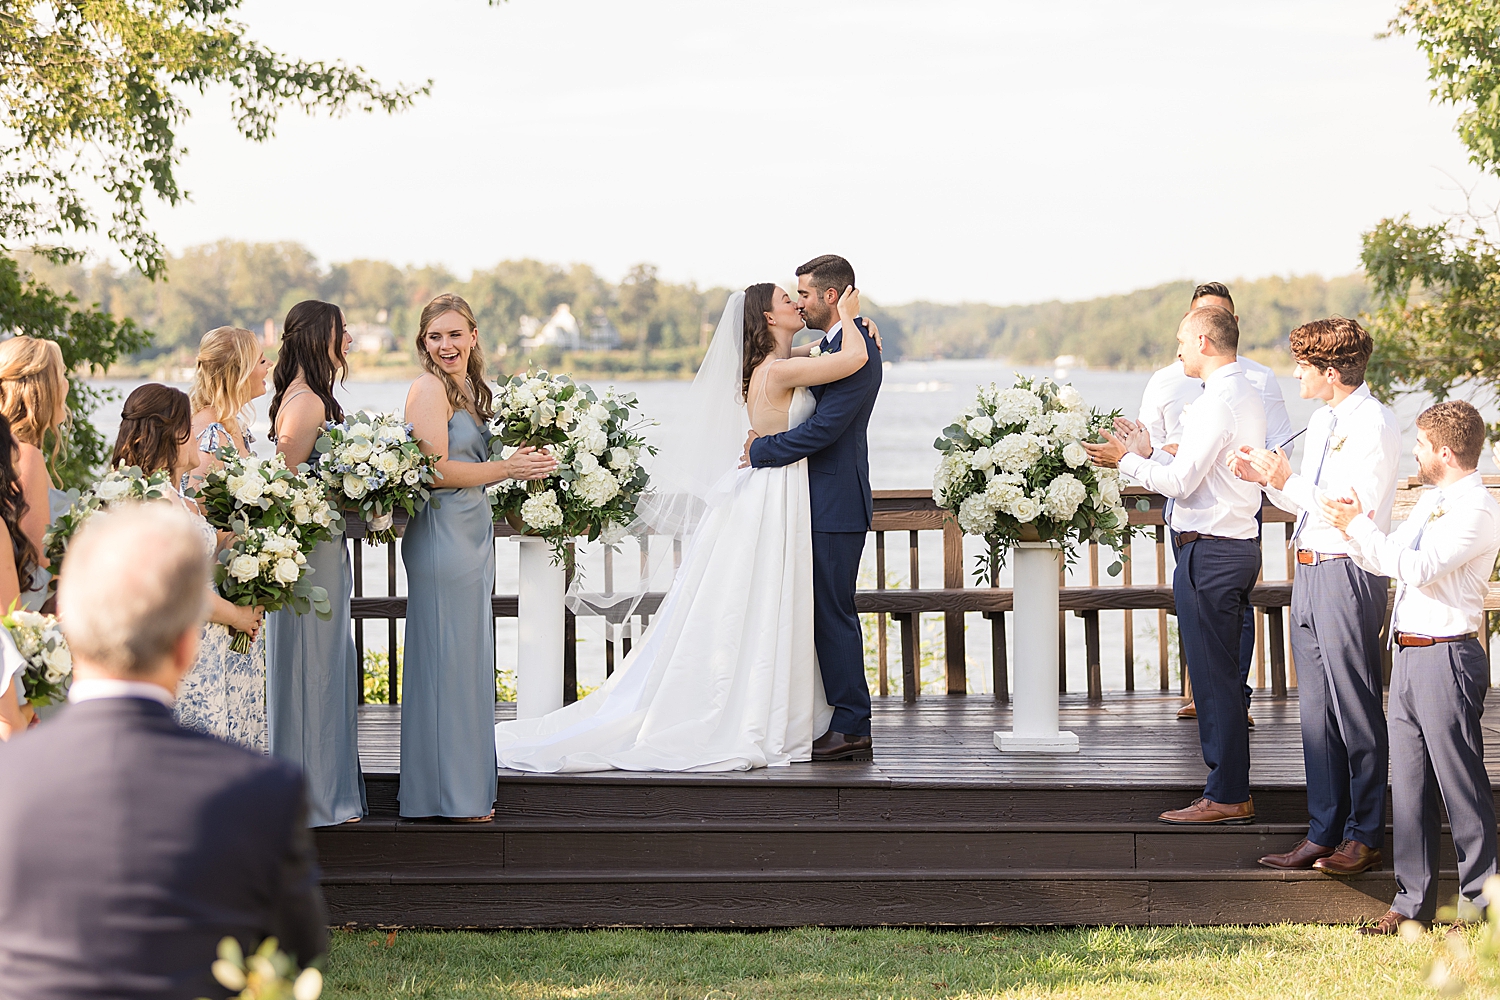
left=1172, top=538, right=1260, bottom=802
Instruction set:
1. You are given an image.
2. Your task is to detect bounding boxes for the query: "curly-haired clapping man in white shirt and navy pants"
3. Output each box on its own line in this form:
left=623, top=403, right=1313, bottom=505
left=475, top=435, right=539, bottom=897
left=1238, top=316, right=1401, bottom=876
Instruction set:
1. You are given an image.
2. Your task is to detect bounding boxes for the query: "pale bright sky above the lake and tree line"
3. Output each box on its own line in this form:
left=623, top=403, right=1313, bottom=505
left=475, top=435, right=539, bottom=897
left=138, top=0, right=1479, bottom=304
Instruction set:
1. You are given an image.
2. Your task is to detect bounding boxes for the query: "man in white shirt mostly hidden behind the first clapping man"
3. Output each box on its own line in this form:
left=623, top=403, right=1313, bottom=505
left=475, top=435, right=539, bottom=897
left=1140, top=282, right=1292, bottom=726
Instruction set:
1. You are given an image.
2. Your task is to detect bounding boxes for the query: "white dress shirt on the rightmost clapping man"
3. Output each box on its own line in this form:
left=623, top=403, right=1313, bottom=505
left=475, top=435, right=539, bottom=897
left=1349, top=472, right=1500, bottom=636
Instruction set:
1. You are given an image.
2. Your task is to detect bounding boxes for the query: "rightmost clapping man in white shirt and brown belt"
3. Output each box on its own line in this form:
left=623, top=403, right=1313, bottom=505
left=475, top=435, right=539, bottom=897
left=1319, top=400, right=1500, bottom=934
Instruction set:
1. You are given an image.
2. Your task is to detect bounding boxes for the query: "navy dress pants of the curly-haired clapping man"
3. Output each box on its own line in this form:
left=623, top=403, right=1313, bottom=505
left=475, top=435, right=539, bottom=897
left=1292, top=559, right=1389, bottom=850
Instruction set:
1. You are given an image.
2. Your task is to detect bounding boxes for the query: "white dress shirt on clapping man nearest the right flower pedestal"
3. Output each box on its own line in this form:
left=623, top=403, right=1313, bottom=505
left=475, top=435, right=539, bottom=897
left=1121, top=361, right=1266, bottom=538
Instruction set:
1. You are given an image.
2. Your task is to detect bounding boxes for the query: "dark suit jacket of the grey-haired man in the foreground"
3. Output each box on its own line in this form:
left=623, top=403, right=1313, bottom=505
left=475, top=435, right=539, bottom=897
left=0, top=697, right=329, bottom=1000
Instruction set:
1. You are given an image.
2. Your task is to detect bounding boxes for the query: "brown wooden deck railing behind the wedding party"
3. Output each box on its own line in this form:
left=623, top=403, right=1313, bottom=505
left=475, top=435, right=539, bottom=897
left=347, top=477, right=1500, bottom=702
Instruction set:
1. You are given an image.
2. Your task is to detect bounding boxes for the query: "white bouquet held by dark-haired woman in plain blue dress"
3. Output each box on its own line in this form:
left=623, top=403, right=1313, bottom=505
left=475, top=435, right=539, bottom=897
left=314, top=409, right=438, bottom=543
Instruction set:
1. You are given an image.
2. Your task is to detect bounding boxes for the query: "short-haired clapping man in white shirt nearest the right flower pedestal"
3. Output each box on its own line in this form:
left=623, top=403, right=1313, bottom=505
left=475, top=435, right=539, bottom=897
left=1086, top=307, right=1266, bottom=825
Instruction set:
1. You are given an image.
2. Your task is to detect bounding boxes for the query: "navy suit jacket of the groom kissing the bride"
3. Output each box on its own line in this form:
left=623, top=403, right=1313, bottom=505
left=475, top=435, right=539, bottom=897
left=750, top=319, right=882, bottom=532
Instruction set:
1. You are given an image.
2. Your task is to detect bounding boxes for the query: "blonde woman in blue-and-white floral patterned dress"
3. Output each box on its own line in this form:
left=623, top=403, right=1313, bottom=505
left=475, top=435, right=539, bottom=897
left=173, top=327, right=270, bottom=754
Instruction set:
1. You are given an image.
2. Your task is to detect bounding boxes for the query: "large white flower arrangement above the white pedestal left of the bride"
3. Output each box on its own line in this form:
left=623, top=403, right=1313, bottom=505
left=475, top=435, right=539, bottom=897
left=489, top=372, right=656, bottom=559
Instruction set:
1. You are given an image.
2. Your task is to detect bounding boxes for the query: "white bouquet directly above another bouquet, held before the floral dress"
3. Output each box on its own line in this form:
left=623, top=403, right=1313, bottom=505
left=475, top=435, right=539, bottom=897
left=194, top=448, right=344, bottom=542
